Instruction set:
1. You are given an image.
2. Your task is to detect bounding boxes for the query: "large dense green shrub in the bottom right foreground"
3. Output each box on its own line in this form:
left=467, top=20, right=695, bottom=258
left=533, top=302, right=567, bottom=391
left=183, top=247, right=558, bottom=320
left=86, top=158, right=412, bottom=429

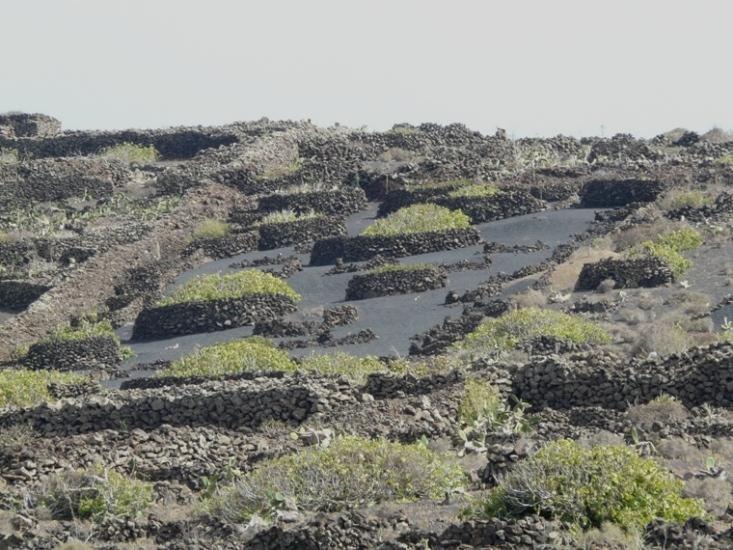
left=465, top=440, right=705, bottom=531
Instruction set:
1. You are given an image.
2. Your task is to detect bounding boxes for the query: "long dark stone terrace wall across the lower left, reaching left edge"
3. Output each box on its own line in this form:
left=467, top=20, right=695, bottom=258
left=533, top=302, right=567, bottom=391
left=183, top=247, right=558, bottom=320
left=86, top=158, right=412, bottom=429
left=0, top=378, right=356, bottom=435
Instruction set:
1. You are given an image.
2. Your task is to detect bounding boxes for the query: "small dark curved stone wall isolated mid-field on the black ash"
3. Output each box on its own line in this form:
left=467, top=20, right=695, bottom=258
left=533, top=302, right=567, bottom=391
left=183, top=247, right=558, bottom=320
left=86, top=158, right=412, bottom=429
left=346, top=266, right=448, bottom=300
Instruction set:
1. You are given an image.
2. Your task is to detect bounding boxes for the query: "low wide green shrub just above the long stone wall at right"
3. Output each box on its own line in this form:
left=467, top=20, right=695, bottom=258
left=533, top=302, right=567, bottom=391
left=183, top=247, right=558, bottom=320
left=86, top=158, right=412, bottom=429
left=453, top=307, right=611, bottom=352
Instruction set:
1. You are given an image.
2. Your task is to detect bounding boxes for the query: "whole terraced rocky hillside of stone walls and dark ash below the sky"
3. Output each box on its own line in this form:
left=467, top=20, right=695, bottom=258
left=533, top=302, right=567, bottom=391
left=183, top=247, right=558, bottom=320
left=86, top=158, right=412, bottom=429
left=0, top=115, right=733, bottom=549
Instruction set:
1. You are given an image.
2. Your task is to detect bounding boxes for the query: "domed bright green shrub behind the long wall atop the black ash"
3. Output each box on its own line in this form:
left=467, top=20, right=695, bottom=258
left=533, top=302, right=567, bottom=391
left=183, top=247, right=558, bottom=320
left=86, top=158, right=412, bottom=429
left=362, top=204, right=471, bottom=237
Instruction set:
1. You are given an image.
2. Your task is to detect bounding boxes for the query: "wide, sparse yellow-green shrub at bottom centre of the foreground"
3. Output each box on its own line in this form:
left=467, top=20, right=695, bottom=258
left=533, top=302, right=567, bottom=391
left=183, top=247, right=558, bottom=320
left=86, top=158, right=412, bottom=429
left=209, top=437, right=465, bottom=523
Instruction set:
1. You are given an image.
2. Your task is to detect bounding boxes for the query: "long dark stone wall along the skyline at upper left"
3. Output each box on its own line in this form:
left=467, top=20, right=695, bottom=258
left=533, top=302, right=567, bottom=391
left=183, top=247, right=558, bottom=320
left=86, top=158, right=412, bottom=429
left=0, top=128, right=238, bottom=160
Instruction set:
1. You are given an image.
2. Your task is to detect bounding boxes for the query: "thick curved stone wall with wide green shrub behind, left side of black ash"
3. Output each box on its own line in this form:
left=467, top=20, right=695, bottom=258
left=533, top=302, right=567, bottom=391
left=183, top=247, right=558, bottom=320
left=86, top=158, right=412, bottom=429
left=132, top=294, right=297, bottom=340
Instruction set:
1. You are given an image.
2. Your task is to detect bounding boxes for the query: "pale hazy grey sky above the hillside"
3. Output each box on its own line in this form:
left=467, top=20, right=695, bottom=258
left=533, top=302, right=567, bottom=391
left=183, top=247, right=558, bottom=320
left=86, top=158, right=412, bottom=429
left=5, top=0, right=733, bottom=136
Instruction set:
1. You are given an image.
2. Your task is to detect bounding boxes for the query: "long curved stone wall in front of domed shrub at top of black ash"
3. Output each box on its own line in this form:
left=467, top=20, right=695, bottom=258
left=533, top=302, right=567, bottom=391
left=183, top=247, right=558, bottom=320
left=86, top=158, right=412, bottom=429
left=311, top=227, right=481, bottom=265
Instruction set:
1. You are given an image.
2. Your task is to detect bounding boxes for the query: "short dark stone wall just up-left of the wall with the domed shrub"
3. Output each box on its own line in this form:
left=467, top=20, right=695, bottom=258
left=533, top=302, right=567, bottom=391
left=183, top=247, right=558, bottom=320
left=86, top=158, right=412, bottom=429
left=259, top=187, right=367, bottom=216
